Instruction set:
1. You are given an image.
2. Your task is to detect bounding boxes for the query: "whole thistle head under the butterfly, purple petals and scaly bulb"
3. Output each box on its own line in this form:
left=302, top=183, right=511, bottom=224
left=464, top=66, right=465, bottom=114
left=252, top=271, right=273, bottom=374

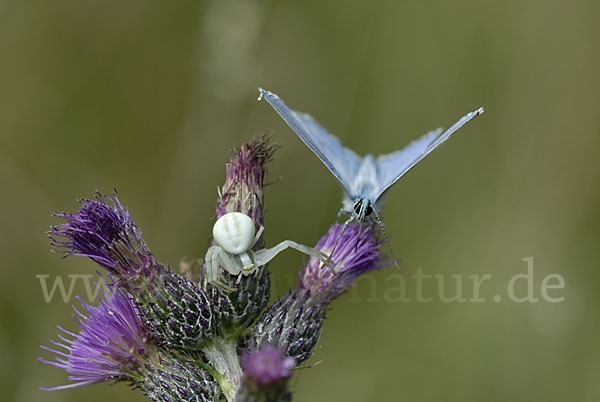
left=253, top=224, right=385, bottom=362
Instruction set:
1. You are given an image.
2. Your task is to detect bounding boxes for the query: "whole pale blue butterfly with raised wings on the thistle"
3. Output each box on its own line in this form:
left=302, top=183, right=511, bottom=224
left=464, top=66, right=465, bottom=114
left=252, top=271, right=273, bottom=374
left=258, top=88, right=483, bottom=226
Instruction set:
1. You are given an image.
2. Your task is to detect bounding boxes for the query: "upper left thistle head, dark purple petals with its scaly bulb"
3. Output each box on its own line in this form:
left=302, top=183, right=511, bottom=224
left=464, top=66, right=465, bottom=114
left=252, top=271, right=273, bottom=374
left=50, top=191, right=215, bottom=350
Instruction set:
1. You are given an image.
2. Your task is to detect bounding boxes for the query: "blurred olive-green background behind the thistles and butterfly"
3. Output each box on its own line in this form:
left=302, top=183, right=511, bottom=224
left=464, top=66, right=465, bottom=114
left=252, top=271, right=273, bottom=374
left=0, top=0, right=600, bottom=402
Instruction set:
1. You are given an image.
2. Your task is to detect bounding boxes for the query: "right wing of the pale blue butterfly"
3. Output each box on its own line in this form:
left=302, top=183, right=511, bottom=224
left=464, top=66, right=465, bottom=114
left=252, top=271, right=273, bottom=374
left=373, top=108, right=483, bottom=200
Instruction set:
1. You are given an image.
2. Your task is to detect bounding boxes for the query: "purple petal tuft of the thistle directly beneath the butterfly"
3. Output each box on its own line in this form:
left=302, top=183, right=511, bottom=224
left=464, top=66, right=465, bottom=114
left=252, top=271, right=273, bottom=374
left=298, top=224, right=386, bottom=301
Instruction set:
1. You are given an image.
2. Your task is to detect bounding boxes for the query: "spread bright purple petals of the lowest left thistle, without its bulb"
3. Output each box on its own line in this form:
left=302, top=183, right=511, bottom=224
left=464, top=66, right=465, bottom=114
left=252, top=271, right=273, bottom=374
left=39, top=278, right=156, bottom=391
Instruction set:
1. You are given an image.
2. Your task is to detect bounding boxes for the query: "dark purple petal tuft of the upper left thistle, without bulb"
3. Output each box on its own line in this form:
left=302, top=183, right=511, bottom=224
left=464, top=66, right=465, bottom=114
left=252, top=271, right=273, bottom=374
left=49, top=191, right=155, bottom=278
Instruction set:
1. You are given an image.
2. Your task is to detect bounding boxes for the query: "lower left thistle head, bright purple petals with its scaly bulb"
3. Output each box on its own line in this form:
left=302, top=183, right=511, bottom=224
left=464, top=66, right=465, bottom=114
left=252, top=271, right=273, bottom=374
left=39, top=278, right=220, bottom=402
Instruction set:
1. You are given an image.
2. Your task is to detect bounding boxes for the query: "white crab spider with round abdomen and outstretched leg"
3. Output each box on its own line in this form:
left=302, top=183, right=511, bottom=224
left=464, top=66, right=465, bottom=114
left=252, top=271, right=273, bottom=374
left=204, top=212, right=329, bottom=292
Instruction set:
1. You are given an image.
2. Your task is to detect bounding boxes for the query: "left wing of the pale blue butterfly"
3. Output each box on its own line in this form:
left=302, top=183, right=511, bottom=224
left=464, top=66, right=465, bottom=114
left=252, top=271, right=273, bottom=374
left=258, top=88, right=362, bottom=196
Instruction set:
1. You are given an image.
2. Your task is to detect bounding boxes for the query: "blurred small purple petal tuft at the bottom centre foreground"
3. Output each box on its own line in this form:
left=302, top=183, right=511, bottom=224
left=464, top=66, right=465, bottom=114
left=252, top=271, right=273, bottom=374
left=242, top=346, right=296, bottom=386
